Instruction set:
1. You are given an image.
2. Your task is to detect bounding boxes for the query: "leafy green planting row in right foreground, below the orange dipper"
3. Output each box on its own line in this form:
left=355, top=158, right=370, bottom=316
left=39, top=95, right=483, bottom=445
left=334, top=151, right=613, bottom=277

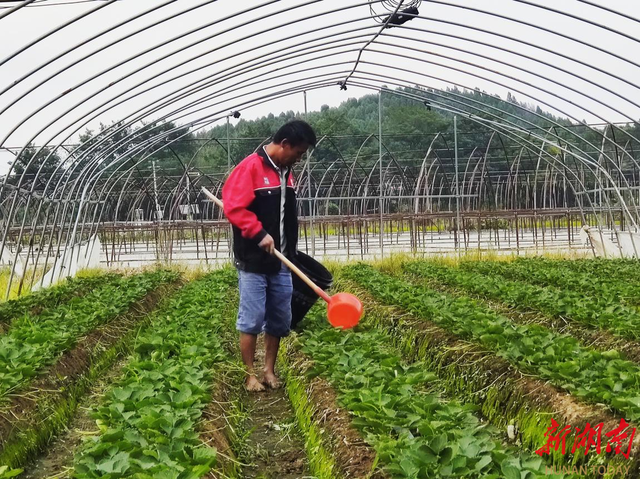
left=288, top=311, right=558, bottom=479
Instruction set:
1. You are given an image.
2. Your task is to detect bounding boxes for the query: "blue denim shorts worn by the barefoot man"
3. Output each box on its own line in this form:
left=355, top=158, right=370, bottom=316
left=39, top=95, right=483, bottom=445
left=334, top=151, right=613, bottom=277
left=236, top=264, right=293, bottom=338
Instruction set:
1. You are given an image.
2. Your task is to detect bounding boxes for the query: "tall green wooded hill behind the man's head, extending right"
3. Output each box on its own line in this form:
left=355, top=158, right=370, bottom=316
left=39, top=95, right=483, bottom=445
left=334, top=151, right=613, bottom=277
left=194, top=88, right=640, bottom=175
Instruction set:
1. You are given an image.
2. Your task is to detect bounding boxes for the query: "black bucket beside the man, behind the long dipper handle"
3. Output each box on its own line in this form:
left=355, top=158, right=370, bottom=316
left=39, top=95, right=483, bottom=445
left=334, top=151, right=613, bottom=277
left=291, top=251, right=333, bottom=329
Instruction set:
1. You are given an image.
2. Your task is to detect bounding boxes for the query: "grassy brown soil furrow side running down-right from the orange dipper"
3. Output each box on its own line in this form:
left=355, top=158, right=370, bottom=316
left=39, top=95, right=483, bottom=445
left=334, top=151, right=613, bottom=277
left=340, top=279, right=640, bottom=477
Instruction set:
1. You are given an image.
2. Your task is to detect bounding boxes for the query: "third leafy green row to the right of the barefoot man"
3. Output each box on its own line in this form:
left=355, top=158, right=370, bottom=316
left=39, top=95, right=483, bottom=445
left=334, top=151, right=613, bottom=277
left=403, top=261, right=640, bottom=339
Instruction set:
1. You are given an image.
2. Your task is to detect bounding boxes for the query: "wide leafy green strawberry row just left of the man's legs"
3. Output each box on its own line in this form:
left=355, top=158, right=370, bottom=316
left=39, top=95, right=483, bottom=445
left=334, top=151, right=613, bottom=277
left=74, top=269, right=236, bottom=479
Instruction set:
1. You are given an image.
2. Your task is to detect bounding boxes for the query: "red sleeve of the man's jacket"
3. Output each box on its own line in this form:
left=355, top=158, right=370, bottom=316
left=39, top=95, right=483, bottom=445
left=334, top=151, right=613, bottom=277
left=222, top=161, right=267, bottom=242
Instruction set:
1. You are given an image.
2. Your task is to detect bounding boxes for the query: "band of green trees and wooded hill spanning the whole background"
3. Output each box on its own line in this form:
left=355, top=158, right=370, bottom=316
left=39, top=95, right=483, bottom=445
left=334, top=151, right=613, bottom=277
left=10, top=88, right=640, bottom=191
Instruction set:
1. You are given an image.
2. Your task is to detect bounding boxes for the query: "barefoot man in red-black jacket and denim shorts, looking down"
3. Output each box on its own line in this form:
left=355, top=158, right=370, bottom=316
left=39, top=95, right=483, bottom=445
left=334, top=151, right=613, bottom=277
left=222, top=120, right=316, bottom=391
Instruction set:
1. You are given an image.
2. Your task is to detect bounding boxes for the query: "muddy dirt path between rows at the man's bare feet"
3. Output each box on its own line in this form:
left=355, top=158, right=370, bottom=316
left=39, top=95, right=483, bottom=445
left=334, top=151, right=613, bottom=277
left=242, top=341, right=311, bottom=479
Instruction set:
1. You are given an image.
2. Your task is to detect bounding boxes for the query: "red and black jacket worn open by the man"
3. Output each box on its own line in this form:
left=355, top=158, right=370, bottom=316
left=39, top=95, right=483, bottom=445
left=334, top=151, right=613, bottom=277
left=222, top=148, right=298, bottom=274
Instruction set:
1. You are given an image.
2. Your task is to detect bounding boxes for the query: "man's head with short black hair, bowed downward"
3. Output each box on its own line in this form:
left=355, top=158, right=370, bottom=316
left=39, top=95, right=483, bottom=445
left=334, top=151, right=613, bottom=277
left=268, top=120, right=316, bottom=168
